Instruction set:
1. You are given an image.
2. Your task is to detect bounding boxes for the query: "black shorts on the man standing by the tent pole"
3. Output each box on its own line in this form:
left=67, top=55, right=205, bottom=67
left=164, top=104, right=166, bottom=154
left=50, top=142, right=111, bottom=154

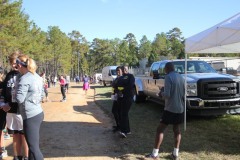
left=160, top=111, right=184, bottom=125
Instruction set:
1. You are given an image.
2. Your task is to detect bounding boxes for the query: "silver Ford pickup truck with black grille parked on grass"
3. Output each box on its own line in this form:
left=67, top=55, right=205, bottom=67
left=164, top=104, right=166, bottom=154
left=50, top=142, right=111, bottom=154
left=134, top=60, right=240, bottom=116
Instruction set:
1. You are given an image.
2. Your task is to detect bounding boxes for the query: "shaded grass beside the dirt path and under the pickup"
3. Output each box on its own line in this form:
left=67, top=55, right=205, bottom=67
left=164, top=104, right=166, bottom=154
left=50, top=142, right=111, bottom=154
left=93, top=85, right=240, bottom=160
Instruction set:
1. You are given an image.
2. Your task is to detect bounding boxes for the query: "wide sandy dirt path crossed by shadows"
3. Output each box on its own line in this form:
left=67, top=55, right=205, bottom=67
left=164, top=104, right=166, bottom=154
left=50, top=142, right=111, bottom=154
left=6, top=83, right=122, bottom=160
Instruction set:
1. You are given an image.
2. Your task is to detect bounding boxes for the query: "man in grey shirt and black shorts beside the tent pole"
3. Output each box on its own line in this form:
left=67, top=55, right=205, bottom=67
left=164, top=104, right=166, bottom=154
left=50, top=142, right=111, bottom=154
left=146, top=62, right=185, bottom=160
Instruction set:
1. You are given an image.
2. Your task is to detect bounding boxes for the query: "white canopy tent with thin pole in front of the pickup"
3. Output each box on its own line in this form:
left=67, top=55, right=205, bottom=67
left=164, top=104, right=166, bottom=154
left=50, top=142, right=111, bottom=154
left=184, top=13, right=240, bottom=130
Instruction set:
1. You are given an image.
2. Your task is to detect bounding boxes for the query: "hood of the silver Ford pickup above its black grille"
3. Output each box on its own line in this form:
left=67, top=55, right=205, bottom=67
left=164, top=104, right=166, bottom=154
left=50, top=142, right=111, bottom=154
left=183, top=73, right=236, bottom=82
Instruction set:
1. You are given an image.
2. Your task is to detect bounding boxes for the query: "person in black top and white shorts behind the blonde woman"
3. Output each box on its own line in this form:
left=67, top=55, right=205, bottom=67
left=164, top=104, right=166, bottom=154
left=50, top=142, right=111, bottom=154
left=2, top=52, right=28, bottom=160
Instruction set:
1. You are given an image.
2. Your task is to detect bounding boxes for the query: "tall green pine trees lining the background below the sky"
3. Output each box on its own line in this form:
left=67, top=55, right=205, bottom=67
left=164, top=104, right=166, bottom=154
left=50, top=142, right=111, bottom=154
left=0, top=0, right=238, bottom=77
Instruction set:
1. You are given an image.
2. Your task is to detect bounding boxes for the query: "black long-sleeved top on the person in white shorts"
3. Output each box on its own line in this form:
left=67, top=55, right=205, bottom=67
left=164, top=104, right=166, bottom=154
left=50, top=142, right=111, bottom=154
left=1, top=71, right=20, bottom=113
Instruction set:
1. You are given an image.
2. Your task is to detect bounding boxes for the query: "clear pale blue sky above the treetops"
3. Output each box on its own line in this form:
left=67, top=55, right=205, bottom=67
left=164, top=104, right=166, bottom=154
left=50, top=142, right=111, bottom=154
left=22, top=0, right=240, bottom=42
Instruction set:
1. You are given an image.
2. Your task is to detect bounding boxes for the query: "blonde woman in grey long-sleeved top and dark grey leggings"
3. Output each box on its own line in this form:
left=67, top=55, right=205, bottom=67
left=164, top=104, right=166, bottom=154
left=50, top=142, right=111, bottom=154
left=16, top=55, right=44, bottom=160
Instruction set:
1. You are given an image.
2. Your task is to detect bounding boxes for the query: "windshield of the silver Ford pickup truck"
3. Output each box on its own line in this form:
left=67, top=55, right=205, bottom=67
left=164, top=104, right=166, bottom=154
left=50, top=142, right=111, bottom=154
left=173, top=61, right=216, bottom=73
